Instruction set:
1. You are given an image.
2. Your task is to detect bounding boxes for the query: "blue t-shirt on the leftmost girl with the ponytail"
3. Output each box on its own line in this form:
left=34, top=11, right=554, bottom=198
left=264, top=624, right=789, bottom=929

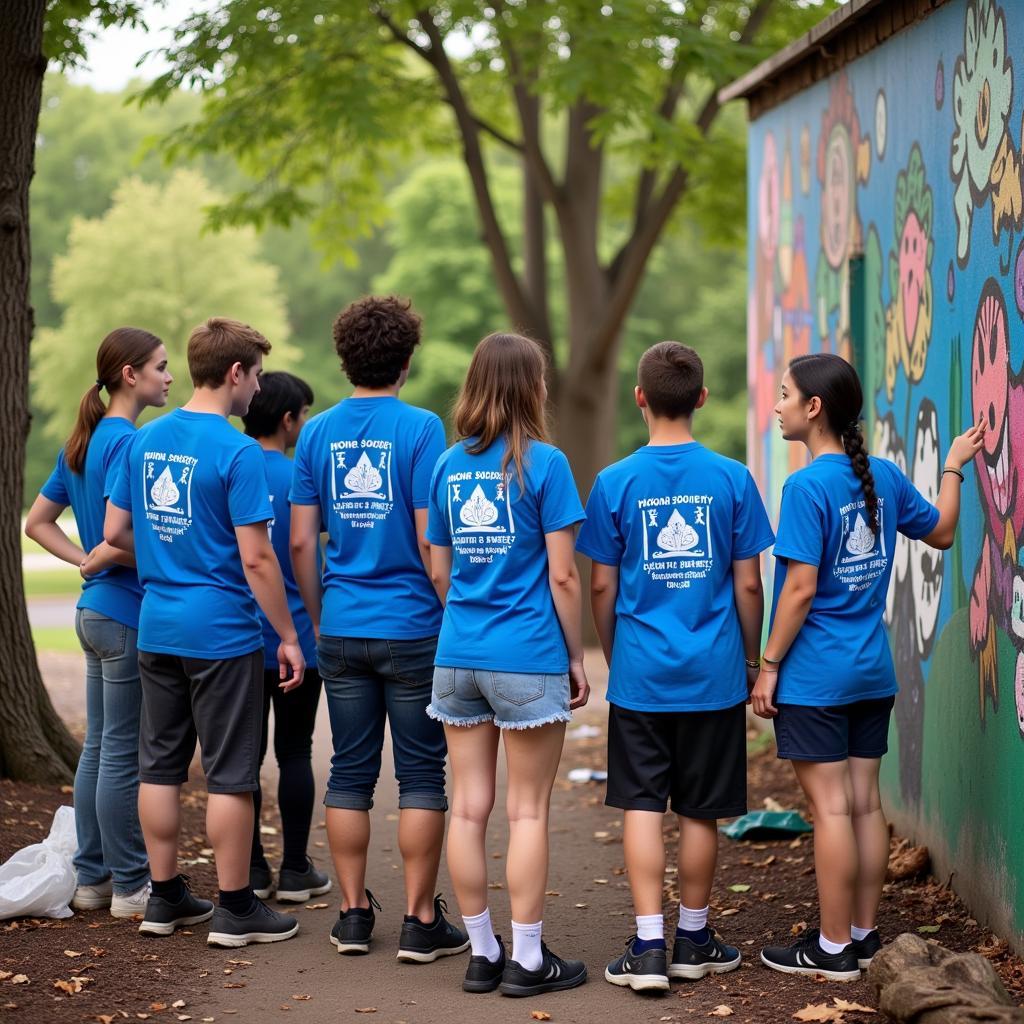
left=40, top=416, right=142, bottom=630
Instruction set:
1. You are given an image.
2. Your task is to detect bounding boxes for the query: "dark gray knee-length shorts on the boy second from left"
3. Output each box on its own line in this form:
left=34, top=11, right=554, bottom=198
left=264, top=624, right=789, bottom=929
left=138, top=647, right=263, bottom=793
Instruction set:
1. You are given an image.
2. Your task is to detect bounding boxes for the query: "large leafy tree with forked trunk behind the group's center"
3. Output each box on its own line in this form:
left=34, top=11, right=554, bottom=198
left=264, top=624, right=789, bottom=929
left=143, top=0, right=837, bottom=488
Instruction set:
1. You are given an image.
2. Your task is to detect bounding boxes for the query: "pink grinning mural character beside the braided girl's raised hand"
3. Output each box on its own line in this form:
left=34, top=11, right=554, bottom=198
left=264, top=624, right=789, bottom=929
left=970, top=278, right=1024, bottom=734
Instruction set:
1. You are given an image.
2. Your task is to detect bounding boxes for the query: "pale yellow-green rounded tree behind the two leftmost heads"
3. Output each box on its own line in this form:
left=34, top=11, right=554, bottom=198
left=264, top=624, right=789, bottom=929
left=33, top=170, right=299, bottom=442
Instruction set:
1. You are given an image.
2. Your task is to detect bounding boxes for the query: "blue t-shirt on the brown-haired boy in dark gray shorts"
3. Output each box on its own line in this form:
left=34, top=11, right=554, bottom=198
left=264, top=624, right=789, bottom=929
left=111, top=409, right=273, bottom=660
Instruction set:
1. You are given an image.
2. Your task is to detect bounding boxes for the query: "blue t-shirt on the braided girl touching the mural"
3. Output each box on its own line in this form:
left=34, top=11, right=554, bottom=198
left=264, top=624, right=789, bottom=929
left=772, top=455, right=939, bottom=707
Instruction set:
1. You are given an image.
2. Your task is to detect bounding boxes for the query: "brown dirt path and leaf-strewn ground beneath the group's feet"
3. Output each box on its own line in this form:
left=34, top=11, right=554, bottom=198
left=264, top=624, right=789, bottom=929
left=0, top=659, right=1024, bottom=1024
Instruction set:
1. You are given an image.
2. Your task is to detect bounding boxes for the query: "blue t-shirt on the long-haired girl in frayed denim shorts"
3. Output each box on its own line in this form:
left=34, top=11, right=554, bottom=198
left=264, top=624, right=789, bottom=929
left=427, top=438, right=585, bottom=673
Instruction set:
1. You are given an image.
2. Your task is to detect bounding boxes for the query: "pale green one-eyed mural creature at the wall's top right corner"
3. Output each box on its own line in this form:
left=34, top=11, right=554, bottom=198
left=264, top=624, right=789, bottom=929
left=949, top=0, right=1024, bottom=273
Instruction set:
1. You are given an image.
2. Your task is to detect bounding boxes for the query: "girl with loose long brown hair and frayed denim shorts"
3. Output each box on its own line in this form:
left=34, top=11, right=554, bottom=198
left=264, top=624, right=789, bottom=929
left=427, top=334, right=589, bottom=995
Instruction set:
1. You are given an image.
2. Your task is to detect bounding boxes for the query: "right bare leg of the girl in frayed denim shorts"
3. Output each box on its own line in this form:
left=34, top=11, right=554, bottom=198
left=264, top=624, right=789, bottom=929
left=502, top=722, right=565, bottom=924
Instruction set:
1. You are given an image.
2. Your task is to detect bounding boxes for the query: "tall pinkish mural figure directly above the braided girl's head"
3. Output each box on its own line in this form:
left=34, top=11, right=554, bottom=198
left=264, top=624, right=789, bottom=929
left=815, top=72, right=871, bottom=359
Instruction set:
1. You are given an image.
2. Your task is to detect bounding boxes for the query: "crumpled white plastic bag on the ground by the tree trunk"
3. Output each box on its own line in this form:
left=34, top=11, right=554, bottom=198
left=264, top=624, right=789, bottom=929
left=0, top=807, right=78, bottom=920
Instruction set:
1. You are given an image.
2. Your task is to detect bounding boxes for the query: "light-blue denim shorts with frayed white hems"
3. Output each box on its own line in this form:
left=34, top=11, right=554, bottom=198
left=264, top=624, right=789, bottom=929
left=427, top=665, right=572, bottom=729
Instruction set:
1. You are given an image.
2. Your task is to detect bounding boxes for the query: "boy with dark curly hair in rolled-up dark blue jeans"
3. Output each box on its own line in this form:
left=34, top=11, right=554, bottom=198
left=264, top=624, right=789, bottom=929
left=290, top=297, right=469, bottom=964
